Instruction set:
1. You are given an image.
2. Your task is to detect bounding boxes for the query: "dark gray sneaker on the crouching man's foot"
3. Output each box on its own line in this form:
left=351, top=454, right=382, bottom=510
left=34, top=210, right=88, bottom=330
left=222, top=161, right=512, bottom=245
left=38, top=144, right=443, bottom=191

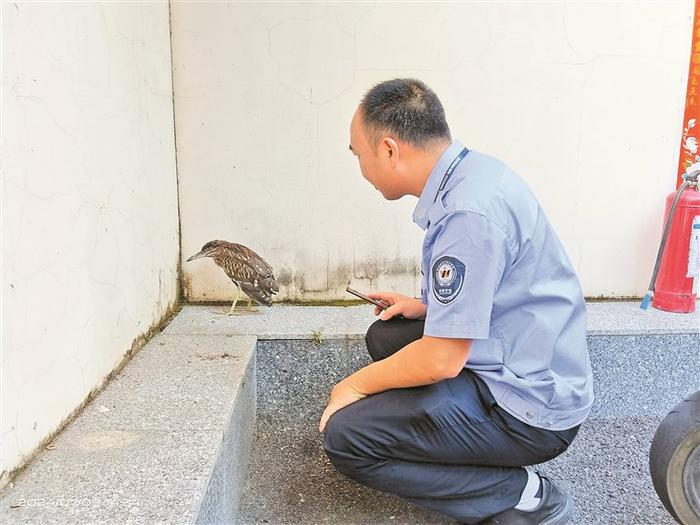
left=481, top=476, right=574, bottom=525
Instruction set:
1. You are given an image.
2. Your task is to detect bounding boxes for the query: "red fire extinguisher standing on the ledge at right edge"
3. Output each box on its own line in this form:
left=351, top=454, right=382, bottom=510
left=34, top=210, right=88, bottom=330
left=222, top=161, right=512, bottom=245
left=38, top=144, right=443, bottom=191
left=641, top=170, right=700, bottom=313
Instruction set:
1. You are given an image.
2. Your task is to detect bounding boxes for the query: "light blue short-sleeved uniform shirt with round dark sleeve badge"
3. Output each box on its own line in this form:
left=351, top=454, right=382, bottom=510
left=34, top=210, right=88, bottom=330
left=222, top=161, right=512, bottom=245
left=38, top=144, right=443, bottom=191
left=413, top=141, right=593, bottom=430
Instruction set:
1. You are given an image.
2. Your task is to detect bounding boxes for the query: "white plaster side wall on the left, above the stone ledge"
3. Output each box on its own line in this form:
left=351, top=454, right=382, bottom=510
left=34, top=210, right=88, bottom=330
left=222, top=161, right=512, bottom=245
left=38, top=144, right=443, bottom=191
left=0, top=2, right=178, bottom=482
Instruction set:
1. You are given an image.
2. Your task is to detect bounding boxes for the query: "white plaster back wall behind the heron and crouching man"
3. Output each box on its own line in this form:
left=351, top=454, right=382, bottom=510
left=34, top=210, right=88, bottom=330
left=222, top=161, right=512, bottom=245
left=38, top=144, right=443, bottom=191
left=172, top=1, right=693, bottom=300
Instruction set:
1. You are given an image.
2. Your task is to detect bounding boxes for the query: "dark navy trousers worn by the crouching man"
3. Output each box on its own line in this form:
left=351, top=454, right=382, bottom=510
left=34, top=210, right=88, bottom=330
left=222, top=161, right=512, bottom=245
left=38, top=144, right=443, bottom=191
left=324, top=319, right=578, bottom=523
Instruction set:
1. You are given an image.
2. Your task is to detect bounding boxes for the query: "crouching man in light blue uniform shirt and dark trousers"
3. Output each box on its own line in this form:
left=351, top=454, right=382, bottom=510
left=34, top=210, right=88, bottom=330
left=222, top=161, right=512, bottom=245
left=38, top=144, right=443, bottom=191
left=319, top=79, right=593, bottom=525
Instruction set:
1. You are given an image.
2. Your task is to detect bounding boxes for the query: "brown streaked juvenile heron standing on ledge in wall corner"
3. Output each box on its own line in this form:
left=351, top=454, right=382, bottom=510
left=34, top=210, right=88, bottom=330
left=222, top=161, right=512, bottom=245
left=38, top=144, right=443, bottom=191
left=187, top=241, right=279, bottom=315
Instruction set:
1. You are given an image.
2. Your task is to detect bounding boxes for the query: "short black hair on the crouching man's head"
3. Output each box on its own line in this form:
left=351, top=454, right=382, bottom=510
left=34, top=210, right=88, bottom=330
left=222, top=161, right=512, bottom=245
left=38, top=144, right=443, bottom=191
left=360, top=78, right=452, bottom=149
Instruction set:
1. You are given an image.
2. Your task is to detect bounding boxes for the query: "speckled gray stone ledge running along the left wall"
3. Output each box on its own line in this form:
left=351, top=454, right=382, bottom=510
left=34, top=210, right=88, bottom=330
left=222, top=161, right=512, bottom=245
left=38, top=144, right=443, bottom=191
left=0, top=333, right=256, bottom=524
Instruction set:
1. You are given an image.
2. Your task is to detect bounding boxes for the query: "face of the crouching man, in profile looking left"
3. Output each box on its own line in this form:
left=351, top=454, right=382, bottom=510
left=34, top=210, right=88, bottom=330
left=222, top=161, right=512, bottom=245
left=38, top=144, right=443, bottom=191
left=350, top=109, right=405, bottom=200
